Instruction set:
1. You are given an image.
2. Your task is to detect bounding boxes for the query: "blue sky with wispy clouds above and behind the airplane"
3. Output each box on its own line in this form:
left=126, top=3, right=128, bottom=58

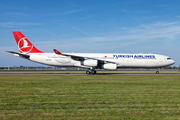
left=0, top=0, right=180, bottom=67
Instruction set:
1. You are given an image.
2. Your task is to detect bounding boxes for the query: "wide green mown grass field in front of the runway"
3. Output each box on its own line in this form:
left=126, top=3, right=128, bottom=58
left=0, top=75, right=180, bottom=120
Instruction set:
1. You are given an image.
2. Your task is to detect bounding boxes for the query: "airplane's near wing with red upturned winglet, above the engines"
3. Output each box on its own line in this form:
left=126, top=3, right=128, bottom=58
left=53, top=49, right=117, bottom=64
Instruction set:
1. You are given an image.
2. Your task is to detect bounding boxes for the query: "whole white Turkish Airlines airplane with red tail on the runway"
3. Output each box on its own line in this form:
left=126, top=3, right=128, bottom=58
left=7, top=31, right=175, bottom=74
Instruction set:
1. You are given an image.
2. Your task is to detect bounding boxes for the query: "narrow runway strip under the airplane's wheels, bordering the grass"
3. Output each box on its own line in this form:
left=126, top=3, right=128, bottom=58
left=0, top=71, right=180, bottom=76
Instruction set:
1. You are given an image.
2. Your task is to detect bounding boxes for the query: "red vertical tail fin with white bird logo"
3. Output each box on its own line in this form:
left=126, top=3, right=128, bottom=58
left=13, top=32, right=43, bottom=53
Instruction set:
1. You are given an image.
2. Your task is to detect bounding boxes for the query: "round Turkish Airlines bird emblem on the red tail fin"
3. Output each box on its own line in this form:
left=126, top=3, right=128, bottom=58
left=18, top=37, right=33, bottom=53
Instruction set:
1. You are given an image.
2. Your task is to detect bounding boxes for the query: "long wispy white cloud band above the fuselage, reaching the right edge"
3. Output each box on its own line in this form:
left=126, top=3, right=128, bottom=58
left=56, top=22, right=180, bottom=46
